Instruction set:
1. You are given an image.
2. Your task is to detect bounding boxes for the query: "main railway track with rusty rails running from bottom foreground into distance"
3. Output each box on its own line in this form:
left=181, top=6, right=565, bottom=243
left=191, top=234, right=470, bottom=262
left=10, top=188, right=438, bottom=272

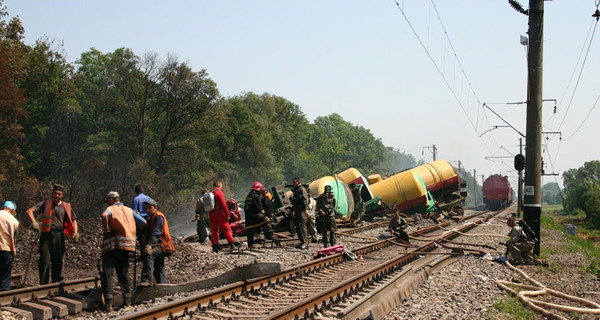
left=117, top=210, right=502, bottom=320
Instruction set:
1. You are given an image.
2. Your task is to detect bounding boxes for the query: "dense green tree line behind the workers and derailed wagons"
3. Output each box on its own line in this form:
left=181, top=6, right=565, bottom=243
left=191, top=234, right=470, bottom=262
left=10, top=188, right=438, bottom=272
left=0, top=4, right=420, bottom=217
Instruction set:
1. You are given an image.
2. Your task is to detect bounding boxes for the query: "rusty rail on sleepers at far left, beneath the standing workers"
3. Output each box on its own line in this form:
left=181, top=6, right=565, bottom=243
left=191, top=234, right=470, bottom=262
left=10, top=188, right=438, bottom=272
left=0, top=277, right=100, bottom=307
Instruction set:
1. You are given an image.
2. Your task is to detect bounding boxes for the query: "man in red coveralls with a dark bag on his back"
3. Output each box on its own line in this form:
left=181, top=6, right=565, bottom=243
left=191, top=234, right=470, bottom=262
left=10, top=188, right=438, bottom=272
left=208, top=180, right=237, bottom=252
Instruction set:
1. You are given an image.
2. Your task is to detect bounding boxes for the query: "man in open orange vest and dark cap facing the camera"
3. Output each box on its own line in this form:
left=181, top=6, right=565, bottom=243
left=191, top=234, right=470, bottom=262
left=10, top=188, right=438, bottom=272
left=25, top=184, right=79, bottom=284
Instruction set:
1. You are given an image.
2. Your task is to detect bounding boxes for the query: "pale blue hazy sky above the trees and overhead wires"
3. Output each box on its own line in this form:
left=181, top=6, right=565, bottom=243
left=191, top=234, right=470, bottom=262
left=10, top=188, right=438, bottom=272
left=4, top=0, right=600, bottom=189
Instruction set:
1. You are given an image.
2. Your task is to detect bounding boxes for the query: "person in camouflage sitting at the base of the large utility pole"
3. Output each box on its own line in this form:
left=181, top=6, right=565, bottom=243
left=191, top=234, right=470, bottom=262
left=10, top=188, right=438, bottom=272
left=505, top=215, right=537, bottom=264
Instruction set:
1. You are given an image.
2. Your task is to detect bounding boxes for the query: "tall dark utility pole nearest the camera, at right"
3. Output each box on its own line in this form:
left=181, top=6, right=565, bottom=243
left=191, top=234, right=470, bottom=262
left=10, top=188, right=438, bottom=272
left=523, top=0, right=544, bottom=255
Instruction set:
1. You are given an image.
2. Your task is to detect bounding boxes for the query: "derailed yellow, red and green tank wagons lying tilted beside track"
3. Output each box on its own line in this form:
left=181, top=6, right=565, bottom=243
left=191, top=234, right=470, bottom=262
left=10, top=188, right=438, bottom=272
left=273, top=160, right=467, bottom=224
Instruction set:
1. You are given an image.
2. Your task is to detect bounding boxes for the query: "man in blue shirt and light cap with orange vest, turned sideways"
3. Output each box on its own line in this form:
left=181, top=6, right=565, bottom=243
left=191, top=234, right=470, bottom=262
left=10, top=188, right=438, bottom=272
left=140, top=199, right=175, bottom=286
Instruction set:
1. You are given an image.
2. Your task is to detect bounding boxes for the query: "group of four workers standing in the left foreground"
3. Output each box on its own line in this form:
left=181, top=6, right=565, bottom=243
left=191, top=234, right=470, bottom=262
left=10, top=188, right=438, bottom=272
left=0, top=184, right=175, bottom=310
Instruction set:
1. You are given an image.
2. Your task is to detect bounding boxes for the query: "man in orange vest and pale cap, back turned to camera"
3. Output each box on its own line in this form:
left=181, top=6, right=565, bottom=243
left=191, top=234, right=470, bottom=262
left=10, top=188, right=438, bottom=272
left=102, top=191, right=146, bottom=311
